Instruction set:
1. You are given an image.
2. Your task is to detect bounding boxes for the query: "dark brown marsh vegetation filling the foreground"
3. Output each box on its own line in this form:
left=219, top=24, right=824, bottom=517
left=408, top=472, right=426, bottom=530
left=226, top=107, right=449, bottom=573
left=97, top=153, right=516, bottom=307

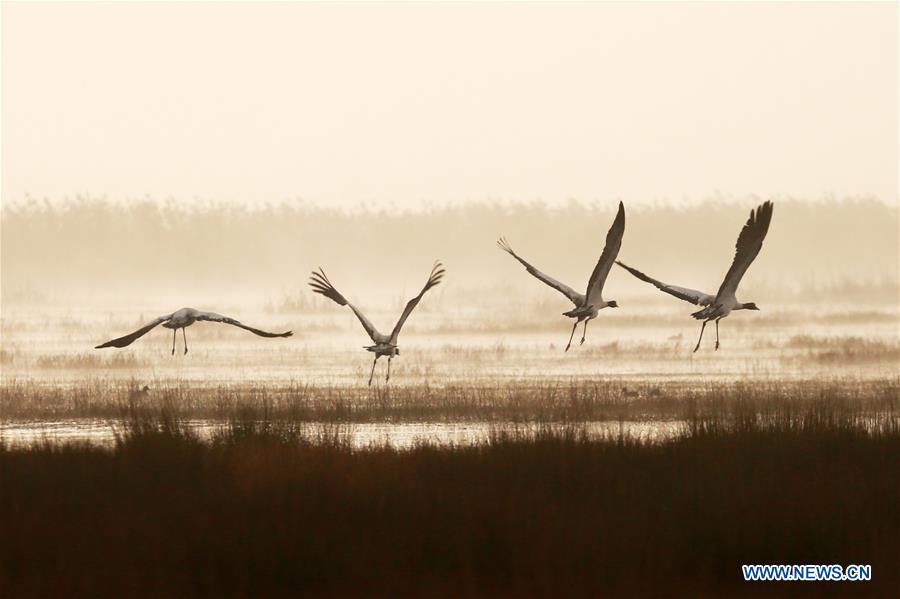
left=0, top=408, right=900, bottom=597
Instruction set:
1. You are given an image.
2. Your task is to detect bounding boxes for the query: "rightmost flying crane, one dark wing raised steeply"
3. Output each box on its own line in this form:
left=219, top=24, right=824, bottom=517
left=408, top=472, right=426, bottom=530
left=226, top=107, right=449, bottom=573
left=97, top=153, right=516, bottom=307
left=616, top=202, right=772, bottom=352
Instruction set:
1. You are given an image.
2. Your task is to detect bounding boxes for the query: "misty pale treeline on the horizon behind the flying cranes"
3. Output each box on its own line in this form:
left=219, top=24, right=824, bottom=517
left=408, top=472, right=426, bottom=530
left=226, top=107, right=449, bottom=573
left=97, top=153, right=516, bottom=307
left=2, top=199, right=898, bottom=300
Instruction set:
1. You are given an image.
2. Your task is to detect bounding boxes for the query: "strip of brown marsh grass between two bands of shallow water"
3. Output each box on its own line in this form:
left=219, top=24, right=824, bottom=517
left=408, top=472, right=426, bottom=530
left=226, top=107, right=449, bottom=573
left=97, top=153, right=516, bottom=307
left=0, top=377, right=900, bottom=423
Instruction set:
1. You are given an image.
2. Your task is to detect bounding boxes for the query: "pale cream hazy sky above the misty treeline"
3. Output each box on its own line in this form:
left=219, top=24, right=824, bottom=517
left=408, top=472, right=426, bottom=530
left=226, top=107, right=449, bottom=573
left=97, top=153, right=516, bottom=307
left=2, top=2, right=898, bottom=207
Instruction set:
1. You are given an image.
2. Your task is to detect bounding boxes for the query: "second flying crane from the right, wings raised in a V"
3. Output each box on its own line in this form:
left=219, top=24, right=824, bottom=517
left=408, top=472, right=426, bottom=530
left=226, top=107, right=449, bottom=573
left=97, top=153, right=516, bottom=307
left=497, top=202, right=625, bottom=351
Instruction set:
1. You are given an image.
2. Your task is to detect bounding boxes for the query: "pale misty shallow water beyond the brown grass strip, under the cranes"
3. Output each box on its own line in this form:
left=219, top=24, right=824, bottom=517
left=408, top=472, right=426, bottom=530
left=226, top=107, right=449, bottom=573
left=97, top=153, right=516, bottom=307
left=2, top=306, right=900, bottom=386
